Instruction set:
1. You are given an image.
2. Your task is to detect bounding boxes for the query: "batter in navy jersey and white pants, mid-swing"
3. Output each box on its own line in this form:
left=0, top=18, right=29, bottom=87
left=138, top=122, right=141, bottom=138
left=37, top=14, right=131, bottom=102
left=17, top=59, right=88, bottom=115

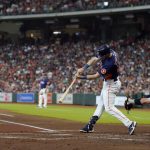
left=76, top=45, right=137, bottom=135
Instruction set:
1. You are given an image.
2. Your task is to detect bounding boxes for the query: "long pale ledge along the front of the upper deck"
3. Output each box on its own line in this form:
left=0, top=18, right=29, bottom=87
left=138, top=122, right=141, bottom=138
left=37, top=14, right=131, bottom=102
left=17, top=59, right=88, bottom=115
left=0, top=5, right=150, bottom=20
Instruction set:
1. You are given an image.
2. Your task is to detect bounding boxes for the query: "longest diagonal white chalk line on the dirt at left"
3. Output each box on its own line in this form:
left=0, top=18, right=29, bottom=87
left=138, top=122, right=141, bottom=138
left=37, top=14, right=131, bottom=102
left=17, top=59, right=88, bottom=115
left=0, top=119, right=56, bottom=132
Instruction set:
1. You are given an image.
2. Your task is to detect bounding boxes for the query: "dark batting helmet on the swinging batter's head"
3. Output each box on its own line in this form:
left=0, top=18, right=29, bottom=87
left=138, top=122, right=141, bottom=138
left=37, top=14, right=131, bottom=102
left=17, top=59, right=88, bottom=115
left=96, top=44, right=110, bottom=57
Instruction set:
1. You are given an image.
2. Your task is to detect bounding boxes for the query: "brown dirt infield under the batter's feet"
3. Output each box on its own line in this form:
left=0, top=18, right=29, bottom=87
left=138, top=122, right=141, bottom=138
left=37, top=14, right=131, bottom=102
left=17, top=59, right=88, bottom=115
left=0, top=110, right=150, bottom=150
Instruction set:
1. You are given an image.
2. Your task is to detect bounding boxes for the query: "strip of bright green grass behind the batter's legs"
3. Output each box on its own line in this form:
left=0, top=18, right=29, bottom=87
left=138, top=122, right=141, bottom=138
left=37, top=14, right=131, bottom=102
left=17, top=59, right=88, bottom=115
left=0, top=103, right=150, bottom=124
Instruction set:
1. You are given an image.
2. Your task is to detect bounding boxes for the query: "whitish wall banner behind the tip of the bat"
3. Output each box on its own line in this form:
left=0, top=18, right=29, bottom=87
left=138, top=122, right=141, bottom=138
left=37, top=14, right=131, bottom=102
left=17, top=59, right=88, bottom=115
left=56, top=93, right=73, bottom=104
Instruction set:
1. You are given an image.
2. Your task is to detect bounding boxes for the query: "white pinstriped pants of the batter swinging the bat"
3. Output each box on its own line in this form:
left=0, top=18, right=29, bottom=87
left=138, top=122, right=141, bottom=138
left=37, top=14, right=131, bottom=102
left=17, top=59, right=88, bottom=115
left=93, top=80, right=132, bottom=127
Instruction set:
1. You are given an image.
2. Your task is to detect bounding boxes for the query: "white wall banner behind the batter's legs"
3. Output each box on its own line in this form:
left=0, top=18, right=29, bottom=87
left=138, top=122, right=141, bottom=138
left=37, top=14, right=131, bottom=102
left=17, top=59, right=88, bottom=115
left=96, top=96, right=127, bottom=106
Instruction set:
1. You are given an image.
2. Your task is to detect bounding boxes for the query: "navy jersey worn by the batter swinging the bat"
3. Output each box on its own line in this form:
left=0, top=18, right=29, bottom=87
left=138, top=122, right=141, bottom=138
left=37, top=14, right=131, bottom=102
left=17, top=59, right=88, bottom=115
left=98, top=50, right=119, bottom=80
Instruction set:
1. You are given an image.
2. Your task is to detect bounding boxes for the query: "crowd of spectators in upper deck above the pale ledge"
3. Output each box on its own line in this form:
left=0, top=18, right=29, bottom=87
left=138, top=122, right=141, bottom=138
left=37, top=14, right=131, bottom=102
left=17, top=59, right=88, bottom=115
left=0, top=0, right=150, bottom=15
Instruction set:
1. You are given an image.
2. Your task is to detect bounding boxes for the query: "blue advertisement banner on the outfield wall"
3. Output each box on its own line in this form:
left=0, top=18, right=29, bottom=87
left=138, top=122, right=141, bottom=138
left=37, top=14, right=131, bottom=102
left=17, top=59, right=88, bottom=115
left=17, top=93, right=34, bottom=103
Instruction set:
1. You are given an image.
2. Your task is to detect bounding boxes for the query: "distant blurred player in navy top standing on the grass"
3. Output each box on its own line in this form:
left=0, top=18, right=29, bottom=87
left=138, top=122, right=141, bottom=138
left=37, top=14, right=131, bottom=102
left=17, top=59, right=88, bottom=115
left=38, top=76, right=48, bottom=108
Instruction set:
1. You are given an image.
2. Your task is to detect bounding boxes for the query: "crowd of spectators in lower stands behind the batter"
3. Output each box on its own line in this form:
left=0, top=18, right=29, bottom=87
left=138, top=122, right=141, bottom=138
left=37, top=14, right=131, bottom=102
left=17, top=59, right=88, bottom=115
left=0, top=38, right=150, bottom=94
